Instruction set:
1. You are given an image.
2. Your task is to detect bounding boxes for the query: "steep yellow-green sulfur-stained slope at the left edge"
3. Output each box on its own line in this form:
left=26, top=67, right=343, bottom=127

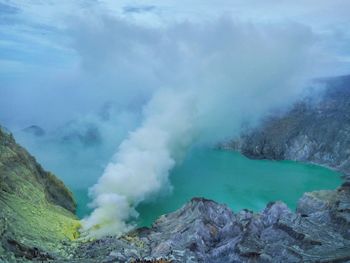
left=0, top=128, right=79, bottom=262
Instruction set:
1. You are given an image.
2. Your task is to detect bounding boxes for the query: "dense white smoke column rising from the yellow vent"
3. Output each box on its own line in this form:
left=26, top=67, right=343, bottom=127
left=84, top=90, right=194, bottom=235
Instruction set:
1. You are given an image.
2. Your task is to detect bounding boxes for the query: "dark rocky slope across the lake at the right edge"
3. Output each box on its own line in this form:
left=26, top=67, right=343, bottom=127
left=223, top=76, right=350, bottom=175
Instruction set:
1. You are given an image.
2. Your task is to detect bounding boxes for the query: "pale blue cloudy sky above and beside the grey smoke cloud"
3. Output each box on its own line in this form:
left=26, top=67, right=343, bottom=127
left=0, top=0, right=350, bottom=129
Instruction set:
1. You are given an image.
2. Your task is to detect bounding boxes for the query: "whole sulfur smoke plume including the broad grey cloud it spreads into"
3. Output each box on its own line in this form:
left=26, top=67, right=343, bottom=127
left=83, top=19, right=317, bottom=236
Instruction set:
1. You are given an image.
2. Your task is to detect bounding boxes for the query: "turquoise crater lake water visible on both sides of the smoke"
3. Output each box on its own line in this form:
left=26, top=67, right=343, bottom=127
left=73, top=149, right=341, bottom=226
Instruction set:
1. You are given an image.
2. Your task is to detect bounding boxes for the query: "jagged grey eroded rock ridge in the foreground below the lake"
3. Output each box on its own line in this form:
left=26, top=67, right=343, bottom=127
left=71, top=183, right=350, bottom=263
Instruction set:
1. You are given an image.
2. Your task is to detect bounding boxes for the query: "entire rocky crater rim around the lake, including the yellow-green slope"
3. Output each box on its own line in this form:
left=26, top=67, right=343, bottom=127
left=0, top=77, right=350, bottom=263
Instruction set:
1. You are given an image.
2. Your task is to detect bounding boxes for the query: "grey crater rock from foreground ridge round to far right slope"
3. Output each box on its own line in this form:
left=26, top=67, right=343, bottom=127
left=69, top=76, right=350, bottom=262
